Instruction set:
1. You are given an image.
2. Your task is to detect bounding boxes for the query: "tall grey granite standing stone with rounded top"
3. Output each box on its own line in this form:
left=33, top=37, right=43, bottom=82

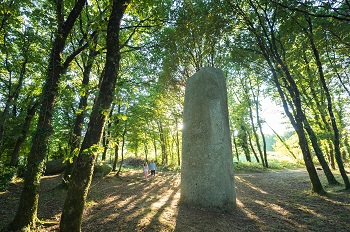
left=181, top=68, right=236, bottom=212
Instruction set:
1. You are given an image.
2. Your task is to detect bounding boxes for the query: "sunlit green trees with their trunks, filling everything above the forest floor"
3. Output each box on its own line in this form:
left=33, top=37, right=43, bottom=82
left=0, top=0, right=350, bottom=231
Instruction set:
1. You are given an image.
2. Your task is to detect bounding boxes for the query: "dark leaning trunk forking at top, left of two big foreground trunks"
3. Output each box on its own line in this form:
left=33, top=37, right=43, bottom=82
left=9, top=0, right=86, bottom=231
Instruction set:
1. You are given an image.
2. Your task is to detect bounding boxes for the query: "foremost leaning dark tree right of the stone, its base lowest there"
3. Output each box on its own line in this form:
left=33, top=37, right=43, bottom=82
left=229, top=1, right=324, bottom=194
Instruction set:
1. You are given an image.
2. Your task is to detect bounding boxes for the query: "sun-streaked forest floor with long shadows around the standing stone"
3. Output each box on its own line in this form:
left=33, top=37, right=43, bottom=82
left=0, top=169, right=350, bottom=232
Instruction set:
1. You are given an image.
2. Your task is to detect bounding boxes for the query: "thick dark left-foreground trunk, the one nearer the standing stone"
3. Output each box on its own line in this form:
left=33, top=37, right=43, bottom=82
left=60, top=0, right=128, bottom=232
